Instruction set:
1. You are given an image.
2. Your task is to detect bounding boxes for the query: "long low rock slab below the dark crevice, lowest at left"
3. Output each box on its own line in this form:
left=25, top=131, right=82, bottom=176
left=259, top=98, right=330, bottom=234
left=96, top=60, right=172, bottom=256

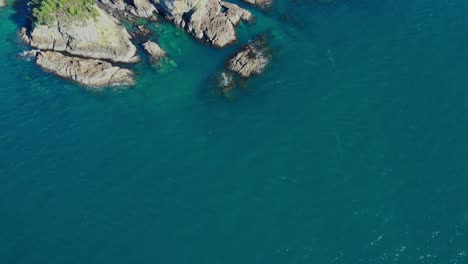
left=36, top=51, right=135, bottom=87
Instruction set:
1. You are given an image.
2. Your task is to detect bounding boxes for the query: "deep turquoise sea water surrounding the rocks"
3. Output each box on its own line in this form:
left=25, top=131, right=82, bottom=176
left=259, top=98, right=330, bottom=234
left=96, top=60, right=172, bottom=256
left=0, top=0, right=468, bottom=264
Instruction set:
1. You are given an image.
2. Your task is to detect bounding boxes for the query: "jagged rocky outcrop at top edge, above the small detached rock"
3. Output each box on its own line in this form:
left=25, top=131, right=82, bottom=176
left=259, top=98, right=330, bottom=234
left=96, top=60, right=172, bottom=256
left=155, top=0, right=252, bottom=47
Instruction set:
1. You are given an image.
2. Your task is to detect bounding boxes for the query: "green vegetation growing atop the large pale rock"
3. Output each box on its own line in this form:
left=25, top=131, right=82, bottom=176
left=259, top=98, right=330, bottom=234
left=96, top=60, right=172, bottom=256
left=32, top=0, right=98, bottom=25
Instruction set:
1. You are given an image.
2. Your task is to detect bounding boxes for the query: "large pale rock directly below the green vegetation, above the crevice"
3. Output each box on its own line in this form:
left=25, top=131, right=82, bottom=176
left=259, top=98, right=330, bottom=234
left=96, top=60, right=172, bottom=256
left=21, top=7, right=138, bottom=63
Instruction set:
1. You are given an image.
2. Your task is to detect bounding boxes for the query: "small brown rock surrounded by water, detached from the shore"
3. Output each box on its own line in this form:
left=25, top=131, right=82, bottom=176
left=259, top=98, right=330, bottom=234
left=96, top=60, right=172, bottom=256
left=228, top=40, right=270, bottom=78
